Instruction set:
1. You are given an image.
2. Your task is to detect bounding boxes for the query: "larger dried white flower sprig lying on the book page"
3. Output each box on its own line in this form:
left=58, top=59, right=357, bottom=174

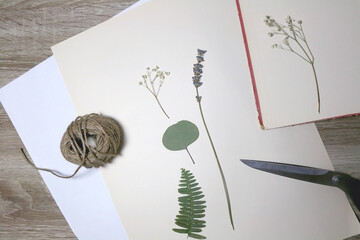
left=264, top=16, right=320, bottom=113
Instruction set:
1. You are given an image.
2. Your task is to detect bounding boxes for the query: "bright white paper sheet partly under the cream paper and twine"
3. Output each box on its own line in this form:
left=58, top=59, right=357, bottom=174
left=0, top=0, right=147, bottom=240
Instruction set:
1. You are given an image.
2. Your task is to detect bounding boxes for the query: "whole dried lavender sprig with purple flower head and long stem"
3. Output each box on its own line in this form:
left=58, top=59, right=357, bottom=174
left=192, top=49, right=235, bottom=229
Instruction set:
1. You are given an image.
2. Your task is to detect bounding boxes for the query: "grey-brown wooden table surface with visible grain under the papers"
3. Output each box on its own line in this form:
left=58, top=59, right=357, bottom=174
left=0, top=0, right=360, bottom=240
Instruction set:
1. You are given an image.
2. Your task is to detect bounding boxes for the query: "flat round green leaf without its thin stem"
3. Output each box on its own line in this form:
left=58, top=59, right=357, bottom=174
left=162, top=120, right=199, bottom=151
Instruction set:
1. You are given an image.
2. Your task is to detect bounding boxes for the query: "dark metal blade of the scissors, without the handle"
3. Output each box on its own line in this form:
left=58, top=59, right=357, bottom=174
left=240, top=159, right=336, bottom=186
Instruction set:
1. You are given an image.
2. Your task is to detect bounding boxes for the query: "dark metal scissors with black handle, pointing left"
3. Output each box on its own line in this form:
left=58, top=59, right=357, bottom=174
left=240, top=159, right=360, bottom=221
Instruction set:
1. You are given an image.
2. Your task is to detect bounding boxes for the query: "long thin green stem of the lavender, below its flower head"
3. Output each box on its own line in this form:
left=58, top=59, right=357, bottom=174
left=196, top=88, right=235, bottom=230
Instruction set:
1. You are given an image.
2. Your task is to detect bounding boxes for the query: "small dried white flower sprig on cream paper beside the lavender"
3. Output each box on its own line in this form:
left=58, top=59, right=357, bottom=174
left=139, top=66, right=170, bottom=118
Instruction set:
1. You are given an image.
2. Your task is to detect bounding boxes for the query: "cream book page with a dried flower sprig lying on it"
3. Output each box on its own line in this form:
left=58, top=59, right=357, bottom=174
left=239, top=0, right=360, bottom=128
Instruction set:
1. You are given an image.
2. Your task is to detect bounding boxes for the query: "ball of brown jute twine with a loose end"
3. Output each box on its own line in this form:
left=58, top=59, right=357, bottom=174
left=21, top=113, right=122, bottom=178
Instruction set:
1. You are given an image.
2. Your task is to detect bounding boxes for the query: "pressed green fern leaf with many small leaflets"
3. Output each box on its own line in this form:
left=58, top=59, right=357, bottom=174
left=173, top=168, right=206, bottom=239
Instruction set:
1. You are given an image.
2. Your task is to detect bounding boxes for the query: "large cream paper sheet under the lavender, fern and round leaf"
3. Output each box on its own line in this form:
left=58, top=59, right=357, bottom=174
left=53, top=0, right=360, bottom=240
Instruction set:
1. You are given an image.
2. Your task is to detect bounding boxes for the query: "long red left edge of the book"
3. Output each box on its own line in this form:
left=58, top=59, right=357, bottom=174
left=236, top=0, right=264, bottom=129
